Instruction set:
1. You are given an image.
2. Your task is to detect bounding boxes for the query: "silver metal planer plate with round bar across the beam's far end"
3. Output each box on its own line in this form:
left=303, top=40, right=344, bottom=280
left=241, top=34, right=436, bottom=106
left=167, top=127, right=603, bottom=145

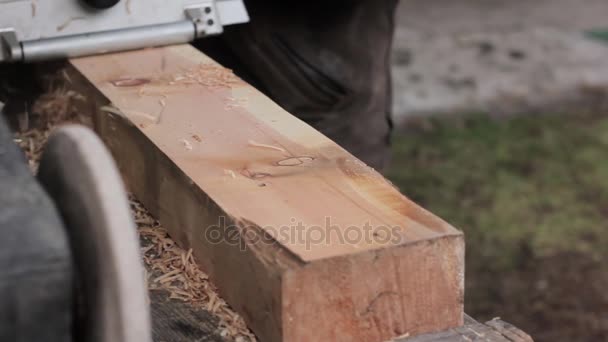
left=0, top=0, right=249, bottom=62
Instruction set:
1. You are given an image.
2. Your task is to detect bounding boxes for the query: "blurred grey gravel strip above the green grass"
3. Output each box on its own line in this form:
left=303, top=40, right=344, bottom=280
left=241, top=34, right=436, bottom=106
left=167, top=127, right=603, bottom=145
left=393, top=0, right=608, bottom=124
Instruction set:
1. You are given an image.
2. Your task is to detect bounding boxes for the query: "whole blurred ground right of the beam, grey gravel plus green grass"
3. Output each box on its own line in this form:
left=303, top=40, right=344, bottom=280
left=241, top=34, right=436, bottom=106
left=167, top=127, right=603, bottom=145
left=389, top=0, right=608, bottom=342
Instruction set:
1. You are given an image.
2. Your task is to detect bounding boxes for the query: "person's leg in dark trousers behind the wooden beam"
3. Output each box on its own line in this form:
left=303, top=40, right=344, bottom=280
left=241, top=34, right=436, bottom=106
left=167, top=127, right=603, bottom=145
left=197, top=0, right=397, bottom=169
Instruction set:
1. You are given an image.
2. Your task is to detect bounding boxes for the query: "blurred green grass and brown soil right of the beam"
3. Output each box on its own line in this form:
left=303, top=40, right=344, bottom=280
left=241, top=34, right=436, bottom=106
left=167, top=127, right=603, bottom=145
left=389, top=115, right=608, bottom=341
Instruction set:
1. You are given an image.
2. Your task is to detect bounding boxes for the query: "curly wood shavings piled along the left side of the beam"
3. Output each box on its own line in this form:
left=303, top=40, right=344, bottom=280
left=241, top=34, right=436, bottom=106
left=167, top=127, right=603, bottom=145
left=14, top=89, right=256, bottom=342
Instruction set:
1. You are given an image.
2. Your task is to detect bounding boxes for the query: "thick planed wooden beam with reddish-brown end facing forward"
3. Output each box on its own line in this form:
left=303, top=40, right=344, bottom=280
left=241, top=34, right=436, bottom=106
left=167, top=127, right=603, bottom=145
left=70, top=46, right=464, bottom=341
